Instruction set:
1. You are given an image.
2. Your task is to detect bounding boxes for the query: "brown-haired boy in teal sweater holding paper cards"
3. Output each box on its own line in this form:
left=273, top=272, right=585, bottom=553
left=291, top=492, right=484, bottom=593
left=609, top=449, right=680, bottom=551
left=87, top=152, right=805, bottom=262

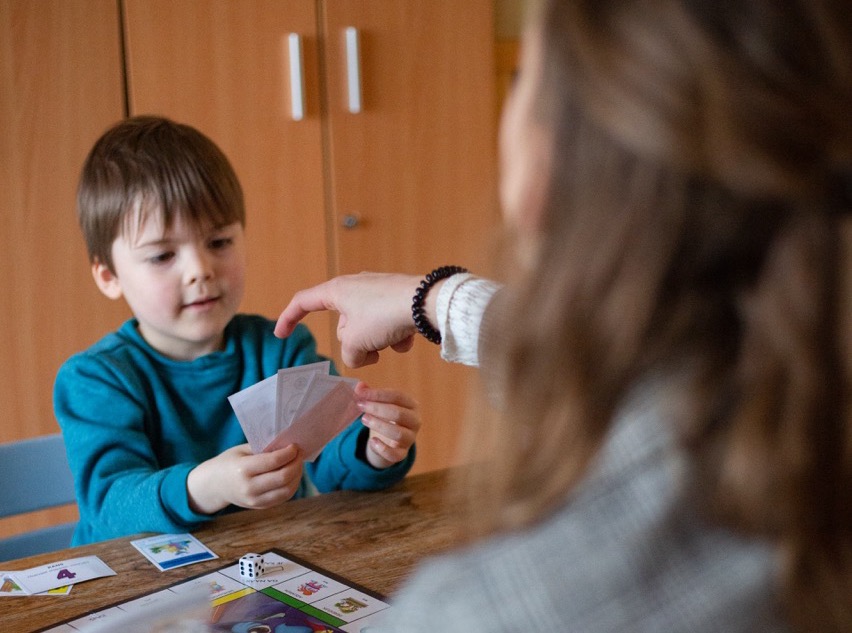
left=54, top=117, right=420, bottom=545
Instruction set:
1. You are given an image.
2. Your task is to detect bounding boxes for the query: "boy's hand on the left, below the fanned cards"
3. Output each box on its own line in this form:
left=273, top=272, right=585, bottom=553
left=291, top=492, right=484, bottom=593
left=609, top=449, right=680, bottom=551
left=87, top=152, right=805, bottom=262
left=186, top=444, right=304, bottom=514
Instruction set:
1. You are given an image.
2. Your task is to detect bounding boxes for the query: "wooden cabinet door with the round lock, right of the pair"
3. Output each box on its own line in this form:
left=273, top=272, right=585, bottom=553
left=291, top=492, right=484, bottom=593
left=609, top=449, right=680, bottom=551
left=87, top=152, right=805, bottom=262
left=323, top=0, right=497, bottom=470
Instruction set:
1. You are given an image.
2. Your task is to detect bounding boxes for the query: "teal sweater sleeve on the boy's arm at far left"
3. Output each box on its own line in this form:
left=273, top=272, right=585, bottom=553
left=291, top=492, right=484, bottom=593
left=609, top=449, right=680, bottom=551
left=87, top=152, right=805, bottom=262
left=54, top=354, right=210, bottom=545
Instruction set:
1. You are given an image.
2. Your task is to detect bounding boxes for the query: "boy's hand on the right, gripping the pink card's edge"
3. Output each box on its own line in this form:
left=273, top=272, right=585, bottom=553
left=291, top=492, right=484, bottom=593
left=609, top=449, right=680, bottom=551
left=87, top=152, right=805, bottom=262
left=355, top=383, right=420, bottom=468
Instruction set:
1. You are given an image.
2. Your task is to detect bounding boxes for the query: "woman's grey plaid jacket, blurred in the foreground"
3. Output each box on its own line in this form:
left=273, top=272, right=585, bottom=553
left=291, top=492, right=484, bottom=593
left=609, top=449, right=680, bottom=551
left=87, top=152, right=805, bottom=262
left=377, top=278, right=788, bottom=633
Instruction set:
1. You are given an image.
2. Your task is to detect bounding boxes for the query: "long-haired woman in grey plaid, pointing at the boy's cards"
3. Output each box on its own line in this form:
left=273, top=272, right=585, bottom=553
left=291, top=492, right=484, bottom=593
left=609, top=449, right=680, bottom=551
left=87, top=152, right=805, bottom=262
left=277, top=0, right=852, bottom=632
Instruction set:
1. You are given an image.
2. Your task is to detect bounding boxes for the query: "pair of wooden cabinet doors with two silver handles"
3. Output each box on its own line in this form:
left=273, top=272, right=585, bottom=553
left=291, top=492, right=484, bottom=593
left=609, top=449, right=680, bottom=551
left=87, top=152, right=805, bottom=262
left=125, top=0, right=496, bottom=470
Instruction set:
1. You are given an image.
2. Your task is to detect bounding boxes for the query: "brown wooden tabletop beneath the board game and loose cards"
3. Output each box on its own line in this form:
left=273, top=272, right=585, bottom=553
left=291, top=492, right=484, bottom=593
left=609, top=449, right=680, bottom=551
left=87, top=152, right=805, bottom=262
left=0, top=471, right=459, bottom=633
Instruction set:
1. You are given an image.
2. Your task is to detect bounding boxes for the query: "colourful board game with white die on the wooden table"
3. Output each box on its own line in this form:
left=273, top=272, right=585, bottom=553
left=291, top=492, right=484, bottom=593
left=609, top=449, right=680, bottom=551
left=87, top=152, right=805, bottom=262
left=36, top=549, right=390, bottom=633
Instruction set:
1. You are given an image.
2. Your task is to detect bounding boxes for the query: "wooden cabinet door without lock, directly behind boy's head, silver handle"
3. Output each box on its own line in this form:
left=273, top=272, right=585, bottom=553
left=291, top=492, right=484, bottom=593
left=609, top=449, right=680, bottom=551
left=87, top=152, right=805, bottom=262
left=125, top=0, right=331, bottom=353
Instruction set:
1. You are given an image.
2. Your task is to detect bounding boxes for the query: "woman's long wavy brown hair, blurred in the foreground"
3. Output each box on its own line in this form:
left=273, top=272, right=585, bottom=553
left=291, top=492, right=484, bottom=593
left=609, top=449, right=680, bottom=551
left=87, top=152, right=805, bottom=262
left=466, top=0, right=852, bottom=631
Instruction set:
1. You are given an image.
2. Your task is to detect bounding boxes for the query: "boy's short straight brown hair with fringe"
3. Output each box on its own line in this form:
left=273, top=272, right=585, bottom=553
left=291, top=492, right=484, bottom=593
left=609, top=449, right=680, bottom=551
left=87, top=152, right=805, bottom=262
left=77, top=116, right=245, bottom=272
